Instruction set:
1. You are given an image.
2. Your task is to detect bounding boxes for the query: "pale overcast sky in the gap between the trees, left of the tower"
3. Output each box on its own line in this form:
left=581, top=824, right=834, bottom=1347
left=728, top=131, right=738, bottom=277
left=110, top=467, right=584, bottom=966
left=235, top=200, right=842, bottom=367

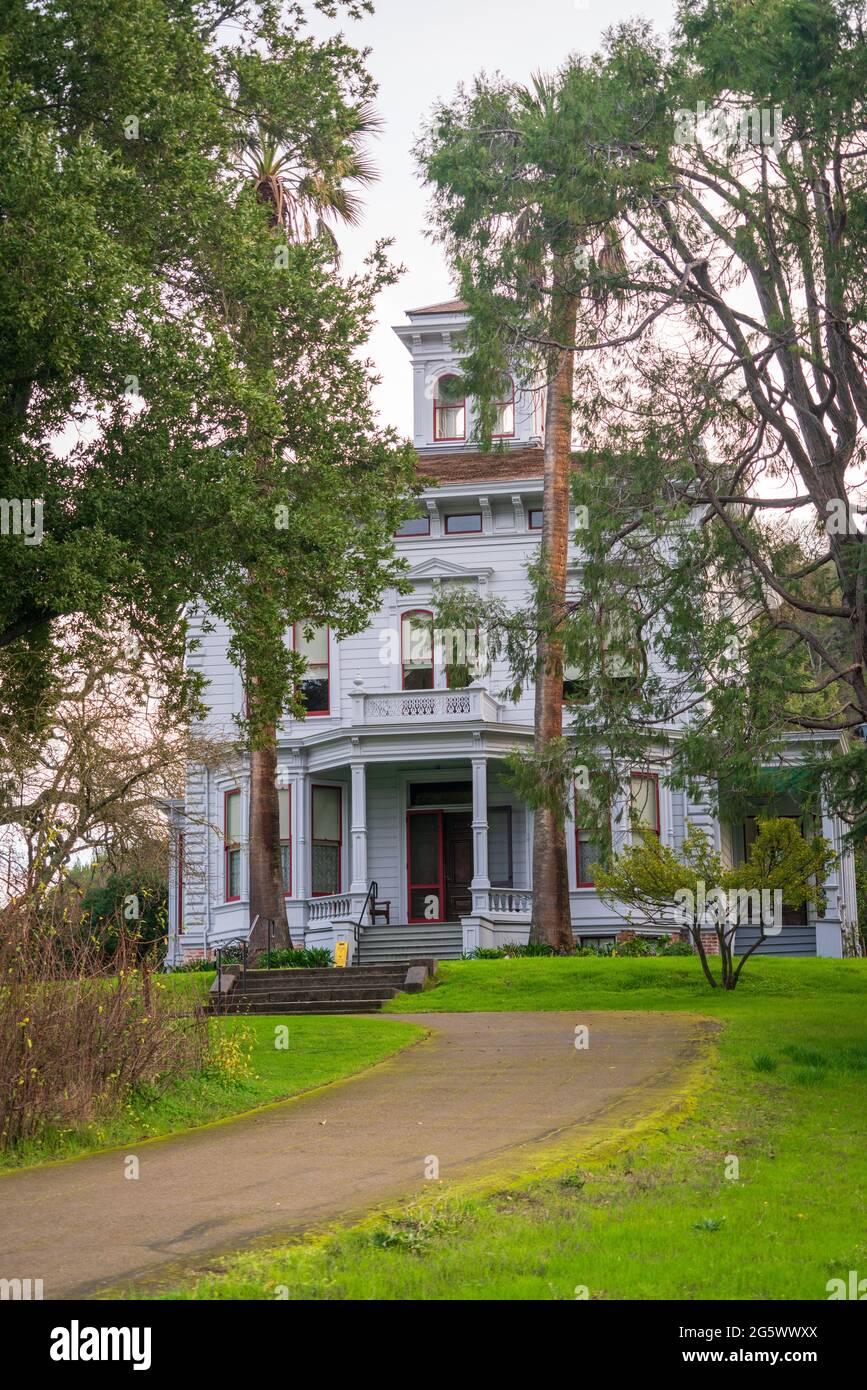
left=304, top=0, right=674, bottom=435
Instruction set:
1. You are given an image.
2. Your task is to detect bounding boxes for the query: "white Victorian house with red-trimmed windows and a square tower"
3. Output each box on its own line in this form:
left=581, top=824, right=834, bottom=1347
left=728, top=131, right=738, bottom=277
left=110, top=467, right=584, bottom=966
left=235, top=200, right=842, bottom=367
left=163, top=302, right=856, bottom=962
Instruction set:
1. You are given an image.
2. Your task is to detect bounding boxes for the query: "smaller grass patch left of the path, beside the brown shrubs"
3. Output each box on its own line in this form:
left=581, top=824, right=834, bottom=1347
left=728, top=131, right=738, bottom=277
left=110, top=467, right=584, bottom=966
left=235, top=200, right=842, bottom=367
left=0, top=1011, right=424, bottom=1172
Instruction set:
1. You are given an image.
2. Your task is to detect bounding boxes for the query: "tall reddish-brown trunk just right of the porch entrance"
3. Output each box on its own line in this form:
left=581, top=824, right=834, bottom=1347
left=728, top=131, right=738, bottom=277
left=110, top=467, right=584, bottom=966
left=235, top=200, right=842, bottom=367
left=529, top=282, right=577, bottom=954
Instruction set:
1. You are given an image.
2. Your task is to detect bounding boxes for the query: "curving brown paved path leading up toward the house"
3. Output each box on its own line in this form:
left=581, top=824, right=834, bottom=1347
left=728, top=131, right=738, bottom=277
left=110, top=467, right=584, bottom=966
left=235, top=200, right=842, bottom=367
left=0, top=1013, right=707, bottom=1298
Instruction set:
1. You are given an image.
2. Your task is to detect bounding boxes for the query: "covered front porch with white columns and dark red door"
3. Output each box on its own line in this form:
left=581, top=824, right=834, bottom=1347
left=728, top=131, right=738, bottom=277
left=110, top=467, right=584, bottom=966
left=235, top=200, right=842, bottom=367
left=280, top=741, right=532, bottom=958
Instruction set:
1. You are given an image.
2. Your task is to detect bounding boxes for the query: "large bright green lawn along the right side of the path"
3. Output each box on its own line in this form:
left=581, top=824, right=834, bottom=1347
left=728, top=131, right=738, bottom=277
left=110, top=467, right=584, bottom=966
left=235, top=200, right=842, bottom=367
left=154, top=958, right=867, bottom=1300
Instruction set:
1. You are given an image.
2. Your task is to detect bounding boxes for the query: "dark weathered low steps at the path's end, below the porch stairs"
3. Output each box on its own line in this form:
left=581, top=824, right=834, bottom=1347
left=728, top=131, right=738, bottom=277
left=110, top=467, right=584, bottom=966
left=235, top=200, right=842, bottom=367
left=210, top=965, right=420, bottom=1013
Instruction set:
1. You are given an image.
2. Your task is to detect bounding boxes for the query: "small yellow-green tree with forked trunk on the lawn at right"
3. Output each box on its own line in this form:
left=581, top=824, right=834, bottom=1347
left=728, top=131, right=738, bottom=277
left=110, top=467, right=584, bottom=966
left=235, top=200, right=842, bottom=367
left=596, top=817, right=834, bottom=990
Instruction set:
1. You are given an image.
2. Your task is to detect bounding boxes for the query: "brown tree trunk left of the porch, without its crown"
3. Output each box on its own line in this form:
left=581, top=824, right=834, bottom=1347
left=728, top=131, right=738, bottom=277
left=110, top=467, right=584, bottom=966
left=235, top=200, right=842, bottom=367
left=247, top=681, right=292, bottom=951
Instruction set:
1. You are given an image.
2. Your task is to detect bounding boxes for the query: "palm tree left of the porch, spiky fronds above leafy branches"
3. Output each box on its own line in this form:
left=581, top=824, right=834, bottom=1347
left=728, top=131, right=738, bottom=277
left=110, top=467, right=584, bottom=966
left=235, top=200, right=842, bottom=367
left=234, top=113, right=378, bottom=947
